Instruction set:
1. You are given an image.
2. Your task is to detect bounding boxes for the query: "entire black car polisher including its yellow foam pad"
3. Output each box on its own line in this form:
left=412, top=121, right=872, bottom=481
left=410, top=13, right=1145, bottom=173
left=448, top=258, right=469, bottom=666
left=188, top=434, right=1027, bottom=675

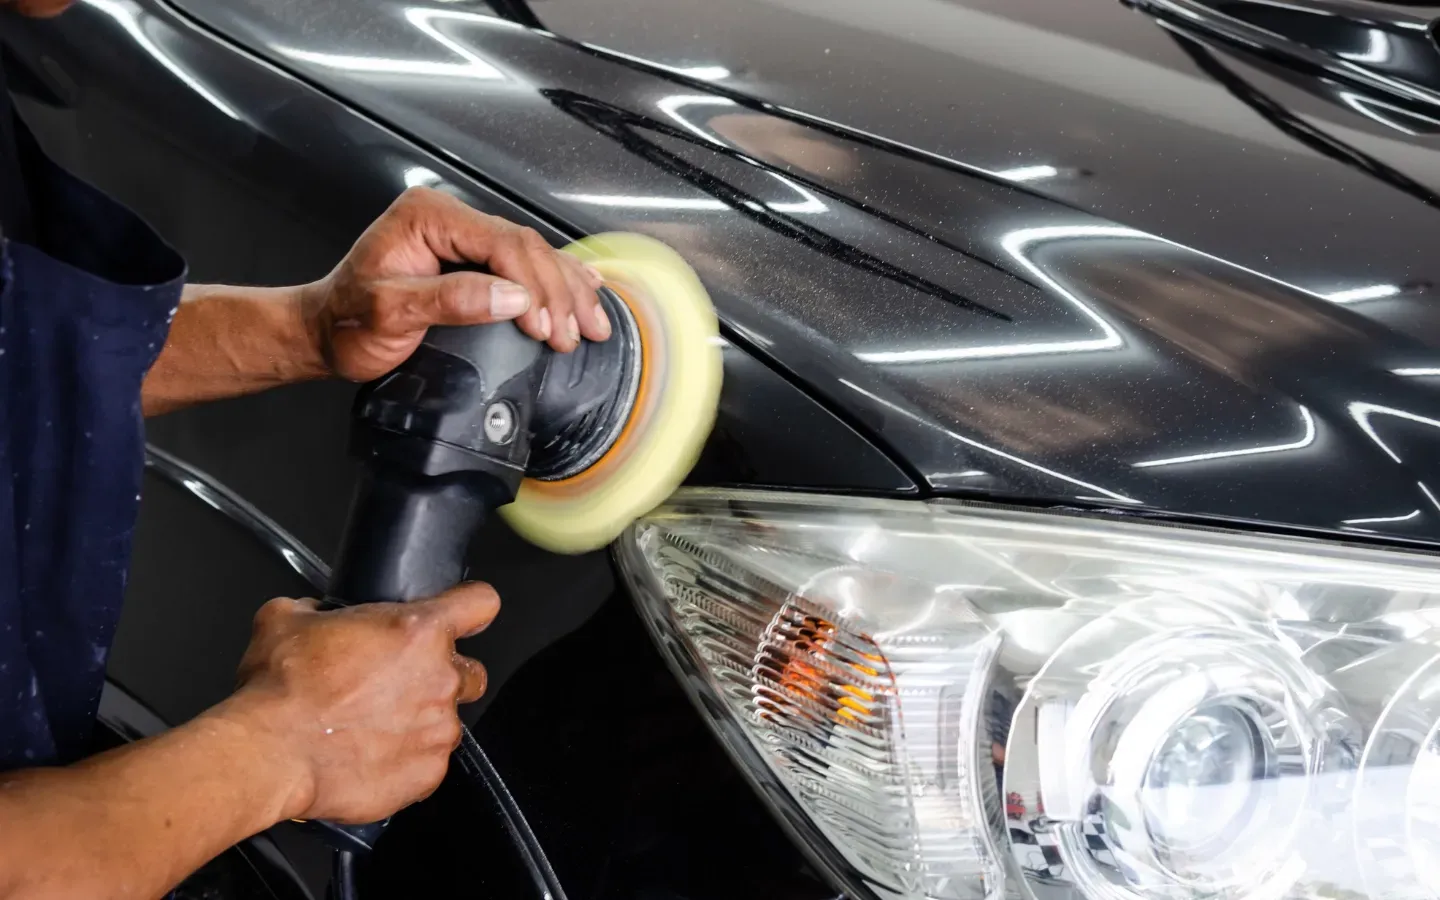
left=315, top=233, right=721, bottom=851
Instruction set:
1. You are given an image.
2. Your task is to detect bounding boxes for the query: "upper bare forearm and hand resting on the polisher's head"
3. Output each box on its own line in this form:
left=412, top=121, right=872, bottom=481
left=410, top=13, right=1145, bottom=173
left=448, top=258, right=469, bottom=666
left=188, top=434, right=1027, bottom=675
left=146, top=191, right=611, bottom=416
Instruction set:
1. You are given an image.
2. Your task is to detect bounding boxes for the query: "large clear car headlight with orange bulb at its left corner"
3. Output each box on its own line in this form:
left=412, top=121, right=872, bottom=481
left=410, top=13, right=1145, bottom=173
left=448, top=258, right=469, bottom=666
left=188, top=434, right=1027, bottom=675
left=619, top=491, right=1440, bottom=900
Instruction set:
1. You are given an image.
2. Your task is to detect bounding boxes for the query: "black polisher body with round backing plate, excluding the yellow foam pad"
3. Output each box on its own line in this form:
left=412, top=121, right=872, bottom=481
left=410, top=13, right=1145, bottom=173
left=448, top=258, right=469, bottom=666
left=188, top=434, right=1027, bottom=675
left=310, top=288, right=627, bottom=852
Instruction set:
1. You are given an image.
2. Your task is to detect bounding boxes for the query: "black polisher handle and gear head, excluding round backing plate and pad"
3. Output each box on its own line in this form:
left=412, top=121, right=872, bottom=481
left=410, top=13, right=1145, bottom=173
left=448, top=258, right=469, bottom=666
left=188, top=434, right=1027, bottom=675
left=305, top=323, right=550, bottom=852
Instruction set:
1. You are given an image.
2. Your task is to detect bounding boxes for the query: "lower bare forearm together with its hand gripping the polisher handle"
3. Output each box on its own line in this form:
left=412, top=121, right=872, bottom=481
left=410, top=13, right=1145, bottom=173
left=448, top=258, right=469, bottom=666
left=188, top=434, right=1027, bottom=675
left=0, top=585, right=500, bottom=900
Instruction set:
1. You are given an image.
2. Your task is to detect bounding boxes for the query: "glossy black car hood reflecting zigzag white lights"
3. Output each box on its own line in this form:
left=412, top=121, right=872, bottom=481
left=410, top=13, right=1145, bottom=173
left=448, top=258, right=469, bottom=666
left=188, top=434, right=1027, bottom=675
left=163, top=0, right=1440, bottom=540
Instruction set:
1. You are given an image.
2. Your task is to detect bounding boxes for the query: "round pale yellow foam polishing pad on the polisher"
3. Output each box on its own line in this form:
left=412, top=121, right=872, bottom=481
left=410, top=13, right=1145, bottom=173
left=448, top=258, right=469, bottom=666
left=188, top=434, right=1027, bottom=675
left=500, top=233, right=721, bottom=553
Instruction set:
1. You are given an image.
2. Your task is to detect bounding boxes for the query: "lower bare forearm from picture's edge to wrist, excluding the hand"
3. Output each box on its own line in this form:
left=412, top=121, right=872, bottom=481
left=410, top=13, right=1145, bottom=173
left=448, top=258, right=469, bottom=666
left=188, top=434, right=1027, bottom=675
left=0, top=697, right=312, bottom=900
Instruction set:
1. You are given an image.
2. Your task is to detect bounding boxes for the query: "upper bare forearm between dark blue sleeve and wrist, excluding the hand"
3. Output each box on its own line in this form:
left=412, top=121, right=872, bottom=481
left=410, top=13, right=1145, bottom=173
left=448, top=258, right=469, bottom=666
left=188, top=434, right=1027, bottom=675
left=141, top=285, right=328, bottom=416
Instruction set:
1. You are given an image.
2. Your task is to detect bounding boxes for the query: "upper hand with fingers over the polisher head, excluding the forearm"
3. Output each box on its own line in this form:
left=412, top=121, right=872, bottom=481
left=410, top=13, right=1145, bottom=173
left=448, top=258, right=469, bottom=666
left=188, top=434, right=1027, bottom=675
left=304, top=187, right=611, bottom=382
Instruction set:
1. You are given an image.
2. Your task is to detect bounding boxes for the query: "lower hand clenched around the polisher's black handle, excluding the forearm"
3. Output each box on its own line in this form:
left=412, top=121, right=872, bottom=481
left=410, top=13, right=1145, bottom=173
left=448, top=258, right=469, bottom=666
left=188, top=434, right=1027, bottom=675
left=222, top=583, right=500, bottom=824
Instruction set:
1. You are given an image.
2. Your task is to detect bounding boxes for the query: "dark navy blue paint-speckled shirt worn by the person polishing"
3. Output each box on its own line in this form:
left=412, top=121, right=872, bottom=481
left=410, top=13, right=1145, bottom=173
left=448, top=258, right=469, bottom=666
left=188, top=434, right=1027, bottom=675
left=0, top=110, right=186, bottom=769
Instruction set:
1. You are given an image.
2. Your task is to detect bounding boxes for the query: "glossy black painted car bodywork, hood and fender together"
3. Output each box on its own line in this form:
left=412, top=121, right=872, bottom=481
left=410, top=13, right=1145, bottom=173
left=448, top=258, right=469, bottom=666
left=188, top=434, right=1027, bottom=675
left=14, top=0, right=1440, bottom=899
